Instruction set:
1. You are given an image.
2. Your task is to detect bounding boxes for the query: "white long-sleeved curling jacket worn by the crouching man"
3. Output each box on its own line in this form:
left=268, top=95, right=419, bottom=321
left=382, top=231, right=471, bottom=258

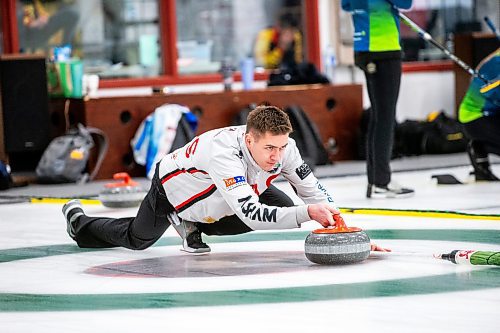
left=159, top=125, right=334, bottom=230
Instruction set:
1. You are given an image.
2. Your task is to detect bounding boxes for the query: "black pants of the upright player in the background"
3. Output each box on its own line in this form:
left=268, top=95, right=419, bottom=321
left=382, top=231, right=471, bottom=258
left=356, top=55, right=401, bottom=186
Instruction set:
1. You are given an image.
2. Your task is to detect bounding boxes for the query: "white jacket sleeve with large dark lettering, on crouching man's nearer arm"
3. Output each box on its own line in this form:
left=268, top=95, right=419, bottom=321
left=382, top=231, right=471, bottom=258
left=208, top=143, right=310, bottom=230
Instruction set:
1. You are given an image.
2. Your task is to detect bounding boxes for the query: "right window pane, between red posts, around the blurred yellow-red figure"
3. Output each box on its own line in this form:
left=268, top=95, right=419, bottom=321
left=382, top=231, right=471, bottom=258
left=176, top=0, right=304, bottom=74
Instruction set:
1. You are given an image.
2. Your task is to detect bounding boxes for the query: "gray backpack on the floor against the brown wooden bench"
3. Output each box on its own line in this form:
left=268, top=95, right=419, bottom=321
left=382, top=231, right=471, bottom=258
left=36, top=124, right=108, bottom=184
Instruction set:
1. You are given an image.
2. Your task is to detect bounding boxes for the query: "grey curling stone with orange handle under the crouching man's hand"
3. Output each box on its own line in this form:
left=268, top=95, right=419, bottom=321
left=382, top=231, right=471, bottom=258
left=305, top=214, right=370, bottom=265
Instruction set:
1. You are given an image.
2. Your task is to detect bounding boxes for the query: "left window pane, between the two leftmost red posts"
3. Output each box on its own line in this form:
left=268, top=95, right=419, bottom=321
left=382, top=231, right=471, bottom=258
left=17, top=0, right=161, bottom=78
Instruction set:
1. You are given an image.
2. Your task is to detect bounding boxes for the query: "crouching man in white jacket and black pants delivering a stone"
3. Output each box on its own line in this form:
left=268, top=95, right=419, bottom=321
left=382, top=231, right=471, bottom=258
left=62, top=106, right=386, bottom=253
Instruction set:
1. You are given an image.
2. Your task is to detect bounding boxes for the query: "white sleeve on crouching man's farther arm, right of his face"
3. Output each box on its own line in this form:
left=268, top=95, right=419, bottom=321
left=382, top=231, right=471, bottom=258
left=281, top=139, right=335, bottom=207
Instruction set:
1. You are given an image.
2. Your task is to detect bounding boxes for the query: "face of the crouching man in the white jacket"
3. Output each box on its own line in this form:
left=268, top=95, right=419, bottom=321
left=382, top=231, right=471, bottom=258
left=245, top=131, right=288, bottom=171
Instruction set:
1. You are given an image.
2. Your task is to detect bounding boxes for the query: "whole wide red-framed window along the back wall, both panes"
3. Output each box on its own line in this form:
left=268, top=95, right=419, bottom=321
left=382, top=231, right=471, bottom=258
left=5, top=0, right=320, bottom=87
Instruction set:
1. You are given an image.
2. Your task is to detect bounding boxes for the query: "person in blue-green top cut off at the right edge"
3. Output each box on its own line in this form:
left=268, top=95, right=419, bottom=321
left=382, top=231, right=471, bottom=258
left=458, top=48, right=500, bottom=181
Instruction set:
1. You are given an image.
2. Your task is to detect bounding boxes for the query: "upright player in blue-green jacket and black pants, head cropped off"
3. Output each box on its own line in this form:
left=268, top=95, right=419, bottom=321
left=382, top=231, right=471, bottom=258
left=342, top=0, right=414, bottom=198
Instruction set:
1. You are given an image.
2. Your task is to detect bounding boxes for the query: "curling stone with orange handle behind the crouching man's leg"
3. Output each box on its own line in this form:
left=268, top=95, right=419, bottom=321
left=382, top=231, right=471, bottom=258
left=99, top=172, right=146, bottom=208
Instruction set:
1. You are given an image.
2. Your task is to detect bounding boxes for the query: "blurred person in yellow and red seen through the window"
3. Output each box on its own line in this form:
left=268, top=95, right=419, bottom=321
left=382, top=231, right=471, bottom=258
left=254, top=14, right=303, bottom=69
